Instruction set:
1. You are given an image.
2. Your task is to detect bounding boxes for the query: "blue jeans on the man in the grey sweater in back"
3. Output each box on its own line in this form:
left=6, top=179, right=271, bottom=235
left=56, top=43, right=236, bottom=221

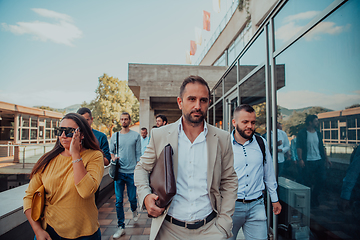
left=114, top=173, right=137, bottom=228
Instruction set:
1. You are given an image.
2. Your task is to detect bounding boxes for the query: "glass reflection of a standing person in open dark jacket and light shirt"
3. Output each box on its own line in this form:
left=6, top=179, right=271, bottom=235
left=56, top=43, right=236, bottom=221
left=296, top=115, right=331, bottom=207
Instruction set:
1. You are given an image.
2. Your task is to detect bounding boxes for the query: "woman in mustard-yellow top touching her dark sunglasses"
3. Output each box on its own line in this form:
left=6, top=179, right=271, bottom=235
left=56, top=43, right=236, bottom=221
left=24, top=113, right=104, bottom=240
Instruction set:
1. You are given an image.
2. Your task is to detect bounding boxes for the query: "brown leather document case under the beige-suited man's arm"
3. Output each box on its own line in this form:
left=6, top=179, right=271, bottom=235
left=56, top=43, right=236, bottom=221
left=150, top=144, right=176, bottom=208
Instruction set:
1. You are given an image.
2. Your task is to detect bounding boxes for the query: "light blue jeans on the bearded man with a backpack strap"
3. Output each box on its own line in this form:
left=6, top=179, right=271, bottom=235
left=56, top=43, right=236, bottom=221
left=229, top=198, right=267, bottom=240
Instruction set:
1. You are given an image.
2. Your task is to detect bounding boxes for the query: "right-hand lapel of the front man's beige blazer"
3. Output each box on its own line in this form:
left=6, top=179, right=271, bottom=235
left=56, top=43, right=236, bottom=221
left=206, top=125, right=218, bottom=193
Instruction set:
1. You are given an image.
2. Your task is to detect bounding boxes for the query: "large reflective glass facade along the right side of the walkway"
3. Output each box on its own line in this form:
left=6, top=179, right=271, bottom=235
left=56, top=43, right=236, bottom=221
left=209, top=0, right=360, bottom=239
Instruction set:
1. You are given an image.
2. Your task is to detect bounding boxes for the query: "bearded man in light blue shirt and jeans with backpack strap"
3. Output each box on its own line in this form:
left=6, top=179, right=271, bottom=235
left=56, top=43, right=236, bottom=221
left=230, top=104, right=281, bottom=240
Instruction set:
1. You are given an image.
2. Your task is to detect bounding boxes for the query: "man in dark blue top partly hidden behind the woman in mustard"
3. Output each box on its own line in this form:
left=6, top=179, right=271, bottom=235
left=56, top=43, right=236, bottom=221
left=77, top=107, right=111, bottom=166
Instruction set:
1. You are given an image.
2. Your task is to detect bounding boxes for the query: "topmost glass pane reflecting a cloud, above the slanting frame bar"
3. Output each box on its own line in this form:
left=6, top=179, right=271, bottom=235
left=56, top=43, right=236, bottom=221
left=274, top=0, right=334, bottom=49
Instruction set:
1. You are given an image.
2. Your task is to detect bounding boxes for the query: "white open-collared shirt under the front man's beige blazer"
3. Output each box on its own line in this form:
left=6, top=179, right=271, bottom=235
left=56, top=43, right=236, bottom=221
left=168, top=119, right=213, bottom=222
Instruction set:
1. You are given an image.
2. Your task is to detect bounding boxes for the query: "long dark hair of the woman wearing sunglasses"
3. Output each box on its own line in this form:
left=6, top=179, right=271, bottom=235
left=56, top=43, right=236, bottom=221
left=30, top=113, right=101, bottom=178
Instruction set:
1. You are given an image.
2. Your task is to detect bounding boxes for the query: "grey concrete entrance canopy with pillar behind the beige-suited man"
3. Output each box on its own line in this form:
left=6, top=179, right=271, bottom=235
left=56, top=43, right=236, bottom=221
left=128, top=63, right=227, bottom=130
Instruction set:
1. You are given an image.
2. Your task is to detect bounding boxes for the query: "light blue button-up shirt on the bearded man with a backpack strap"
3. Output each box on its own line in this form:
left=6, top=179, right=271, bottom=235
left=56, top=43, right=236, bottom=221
left=231, top=130, right=279, bottom=202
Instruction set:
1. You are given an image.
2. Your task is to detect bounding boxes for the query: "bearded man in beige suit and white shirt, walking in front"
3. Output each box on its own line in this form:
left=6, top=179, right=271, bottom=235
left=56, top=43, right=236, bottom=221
left=135, top=76, right=237, bottom=240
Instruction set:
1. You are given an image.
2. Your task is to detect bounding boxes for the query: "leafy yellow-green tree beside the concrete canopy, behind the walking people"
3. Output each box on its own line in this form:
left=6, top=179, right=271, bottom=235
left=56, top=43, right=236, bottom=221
left=82, top=73, right=139, bottom=136
